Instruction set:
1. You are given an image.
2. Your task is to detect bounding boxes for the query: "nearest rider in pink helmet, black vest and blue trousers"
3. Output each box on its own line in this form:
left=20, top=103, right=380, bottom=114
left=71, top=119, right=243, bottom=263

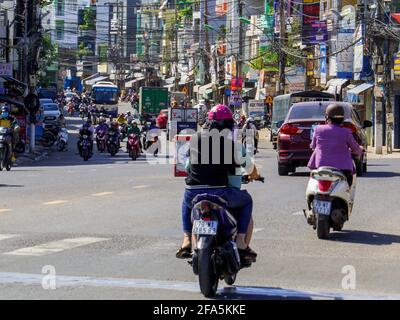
left=176, top=104, right=260, bottom=261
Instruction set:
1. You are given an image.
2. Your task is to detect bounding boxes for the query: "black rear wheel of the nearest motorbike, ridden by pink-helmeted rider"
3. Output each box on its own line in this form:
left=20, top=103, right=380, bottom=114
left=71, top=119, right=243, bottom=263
left=197, top=248, right=219, bottom=297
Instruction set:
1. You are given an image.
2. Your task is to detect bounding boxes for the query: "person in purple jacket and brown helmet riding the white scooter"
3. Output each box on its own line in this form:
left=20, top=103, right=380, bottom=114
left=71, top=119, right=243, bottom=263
left=308, top=103, right=363, bottom=186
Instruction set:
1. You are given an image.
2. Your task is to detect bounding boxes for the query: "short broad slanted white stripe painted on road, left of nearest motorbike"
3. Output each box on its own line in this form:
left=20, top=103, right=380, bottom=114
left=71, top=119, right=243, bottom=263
left=4, top=237, right=110, bottom=256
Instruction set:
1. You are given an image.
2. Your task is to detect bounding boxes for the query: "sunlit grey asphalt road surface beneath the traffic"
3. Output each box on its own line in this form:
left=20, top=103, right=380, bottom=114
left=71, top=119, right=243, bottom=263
left=0, top=103, right=400, bottom=299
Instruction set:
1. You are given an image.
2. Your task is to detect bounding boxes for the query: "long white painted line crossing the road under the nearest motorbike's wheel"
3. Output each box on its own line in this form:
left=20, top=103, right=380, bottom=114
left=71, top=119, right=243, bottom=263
left=0, top=272, right=400, bottom=300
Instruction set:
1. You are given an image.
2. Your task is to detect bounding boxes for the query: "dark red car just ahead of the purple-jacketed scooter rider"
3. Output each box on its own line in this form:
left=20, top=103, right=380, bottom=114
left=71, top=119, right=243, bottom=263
left=278, top=101, right=372, bottom=176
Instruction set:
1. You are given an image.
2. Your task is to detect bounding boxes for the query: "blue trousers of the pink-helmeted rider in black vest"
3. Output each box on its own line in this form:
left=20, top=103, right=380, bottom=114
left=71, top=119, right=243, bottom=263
left=182, top=187, right=253, bottom=233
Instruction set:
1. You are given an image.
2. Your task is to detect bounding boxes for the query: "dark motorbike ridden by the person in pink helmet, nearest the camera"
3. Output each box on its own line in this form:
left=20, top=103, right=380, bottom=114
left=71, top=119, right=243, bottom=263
left=189, top=176, right=264, bottom=297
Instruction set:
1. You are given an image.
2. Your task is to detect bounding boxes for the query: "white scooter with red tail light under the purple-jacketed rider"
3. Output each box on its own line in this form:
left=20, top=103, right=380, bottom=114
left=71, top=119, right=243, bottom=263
left=304, top=167, right=357, bottom=239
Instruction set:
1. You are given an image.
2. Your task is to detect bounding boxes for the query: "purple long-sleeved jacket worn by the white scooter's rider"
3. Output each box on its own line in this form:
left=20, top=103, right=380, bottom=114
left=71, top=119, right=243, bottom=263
left=308, top=124, right=363, bottom=172
